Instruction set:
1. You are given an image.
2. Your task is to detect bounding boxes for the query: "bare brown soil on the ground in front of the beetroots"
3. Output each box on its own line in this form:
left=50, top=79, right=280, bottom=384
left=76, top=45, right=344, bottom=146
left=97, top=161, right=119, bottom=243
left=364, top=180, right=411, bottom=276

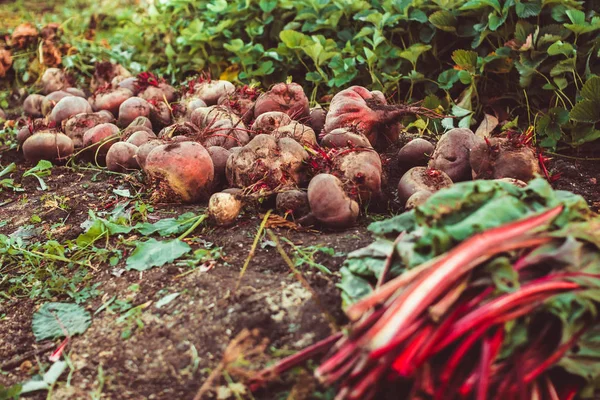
left=0, top=141, right=600, bottom=399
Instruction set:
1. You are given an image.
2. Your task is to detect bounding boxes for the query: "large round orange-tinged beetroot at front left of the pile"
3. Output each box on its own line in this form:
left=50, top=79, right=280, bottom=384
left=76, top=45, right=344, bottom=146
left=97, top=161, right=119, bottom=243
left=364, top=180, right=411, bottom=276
left=144, top=142, right=214, bottom=203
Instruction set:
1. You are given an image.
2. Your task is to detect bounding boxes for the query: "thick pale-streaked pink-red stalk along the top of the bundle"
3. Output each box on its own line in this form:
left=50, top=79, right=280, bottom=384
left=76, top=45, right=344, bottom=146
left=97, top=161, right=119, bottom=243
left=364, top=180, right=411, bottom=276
left=368, top=205, right=563, bottom=350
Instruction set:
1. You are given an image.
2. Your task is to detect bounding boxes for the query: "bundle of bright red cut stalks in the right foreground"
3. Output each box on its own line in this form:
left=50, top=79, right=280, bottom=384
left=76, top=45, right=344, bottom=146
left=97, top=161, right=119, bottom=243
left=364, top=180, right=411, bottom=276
left=251, top=206, right=600, bottom=400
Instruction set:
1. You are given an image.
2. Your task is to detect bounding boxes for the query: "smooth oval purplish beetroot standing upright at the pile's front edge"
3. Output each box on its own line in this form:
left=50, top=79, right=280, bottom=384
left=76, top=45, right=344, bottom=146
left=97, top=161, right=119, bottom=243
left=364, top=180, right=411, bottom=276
left=308, top=174, right=359, bottom=228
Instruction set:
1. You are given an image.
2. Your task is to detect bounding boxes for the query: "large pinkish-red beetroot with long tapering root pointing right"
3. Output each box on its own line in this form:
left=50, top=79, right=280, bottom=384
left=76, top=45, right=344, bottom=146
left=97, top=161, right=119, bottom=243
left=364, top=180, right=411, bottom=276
left=323, top=86, right=439, bottom=149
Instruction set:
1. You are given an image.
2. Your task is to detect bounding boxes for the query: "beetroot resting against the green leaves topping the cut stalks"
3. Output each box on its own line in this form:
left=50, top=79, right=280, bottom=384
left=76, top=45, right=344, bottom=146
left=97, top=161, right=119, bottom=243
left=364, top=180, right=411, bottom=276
left=398, top=167, right=452, bottom=205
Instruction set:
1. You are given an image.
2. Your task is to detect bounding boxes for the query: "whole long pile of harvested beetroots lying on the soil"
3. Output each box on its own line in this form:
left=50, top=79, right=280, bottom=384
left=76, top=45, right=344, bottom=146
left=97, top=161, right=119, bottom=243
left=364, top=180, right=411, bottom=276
left=18, top=63, right=540, bottom=227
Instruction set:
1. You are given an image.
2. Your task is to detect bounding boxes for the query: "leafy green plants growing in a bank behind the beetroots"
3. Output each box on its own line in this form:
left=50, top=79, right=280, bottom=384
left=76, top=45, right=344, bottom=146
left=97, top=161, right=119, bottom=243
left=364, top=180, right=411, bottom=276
left=0, top=0, right=600, bottom=147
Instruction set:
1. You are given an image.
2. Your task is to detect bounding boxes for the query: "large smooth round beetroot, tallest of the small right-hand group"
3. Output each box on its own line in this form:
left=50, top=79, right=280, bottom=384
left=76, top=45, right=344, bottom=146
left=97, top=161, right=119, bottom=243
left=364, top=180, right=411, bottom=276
left=428, top=128, right=485, bottom=182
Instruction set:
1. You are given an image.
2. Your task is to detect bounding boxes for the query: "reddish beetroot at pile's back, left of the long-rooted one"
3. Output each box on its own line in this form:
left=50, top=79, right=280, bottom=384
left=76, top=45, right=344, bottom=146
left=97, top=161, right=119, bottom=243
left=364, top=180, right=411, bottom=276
left=254, top=83, right=310, bottom=121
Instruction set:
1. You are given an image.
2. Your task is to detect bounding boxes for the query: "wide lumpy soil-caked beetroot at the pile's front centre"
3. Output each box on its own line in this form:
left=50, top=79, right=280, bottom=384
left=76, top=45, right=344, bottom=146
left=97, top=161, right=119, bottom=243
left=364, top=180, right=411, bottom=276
left=226, top=135, right=308, bottom=190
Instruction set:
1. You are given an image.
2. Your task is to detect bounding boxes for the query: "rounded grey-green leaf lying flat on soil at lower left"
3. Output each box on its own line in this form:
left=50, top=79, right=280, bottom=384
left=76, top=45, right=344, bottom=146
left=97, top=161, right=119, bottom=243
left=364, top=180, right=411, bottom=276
left=32, top=303, right=92, bottom=342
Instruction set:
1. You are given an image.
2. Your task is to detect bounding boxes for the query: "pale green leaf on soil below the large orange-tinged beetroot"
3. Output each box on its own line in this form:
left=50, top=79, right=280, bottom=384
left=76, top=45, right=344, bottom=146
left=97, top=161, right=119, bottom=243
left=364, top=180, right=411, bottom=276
left=126, top=239, right=192, bottom=271
